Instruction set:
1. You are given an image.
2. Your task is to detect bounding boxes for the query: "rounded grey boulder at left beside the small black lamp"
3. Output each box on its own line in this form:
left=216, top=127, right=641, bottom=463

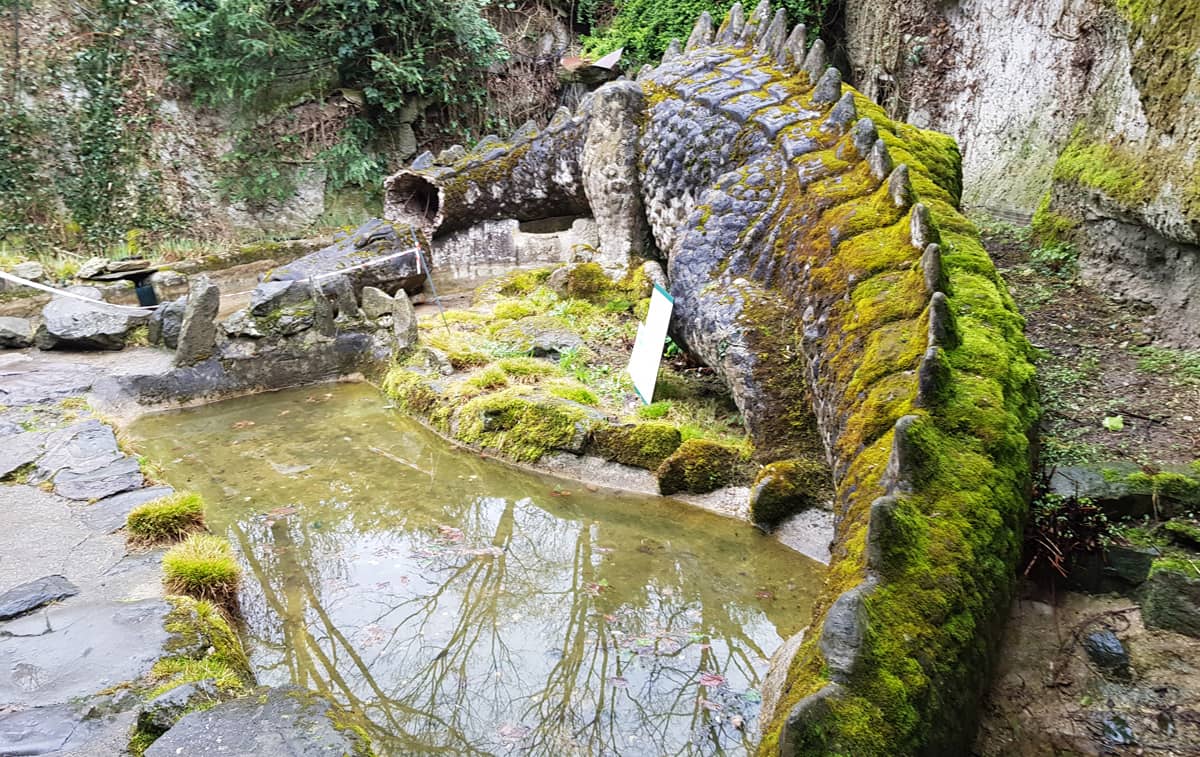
left=34, top=287, right=150, bottom=349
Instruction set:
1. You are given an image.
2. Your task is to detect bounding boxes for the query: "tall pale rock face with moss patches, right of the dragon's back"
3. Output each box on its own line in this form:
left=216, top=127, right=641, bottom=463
left=841, top=0, right=1200, bottom=346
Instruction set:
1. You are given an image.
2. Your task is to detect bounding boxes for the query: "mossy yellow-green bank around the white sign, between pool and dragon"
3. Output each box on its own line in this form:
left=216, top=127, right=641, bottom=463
left=383, top=264, right=752, bottom=493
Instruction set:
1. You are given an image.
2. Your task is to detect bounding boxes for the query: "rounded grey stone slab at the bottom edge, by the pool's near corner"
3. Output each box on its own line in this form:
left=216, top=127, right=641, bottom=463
left=145, top=689, right=360, bottom=757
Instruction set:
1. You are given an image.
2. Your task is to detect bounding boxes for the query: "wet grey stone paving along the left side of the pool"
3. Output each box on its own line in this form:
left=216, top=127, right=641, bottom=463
left=0, top=353, right=170, bottom=756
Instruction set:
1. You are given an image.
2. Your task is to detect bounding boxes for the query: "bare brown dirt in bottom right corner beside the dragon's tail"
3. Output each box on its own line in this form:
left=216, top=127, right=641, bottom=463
left=976, top=594, right=1200, bottom=757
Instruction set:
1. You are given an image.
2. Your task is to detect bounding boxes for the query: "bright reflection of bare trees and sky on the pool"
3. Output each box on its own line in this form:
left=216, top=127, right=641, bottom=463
left=230, top=498, right=764, bottom=755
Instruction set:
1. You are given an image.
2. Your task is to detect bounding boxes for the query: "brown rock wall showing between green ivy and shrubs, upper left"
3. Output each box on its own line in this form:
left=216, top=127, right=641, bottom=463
left=0, top=0, right=571, bottom=239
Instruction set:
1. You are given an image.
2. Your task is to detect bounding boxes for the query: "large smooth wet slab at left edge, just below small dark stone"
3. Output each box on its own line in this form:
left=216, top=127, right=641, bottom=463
left=0, top=597, right=170, bottom=707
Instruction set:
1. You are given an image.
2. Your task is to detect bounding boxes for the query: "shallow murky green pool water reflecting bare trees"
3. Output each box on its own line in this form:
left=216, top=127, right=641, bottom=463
left=131, top=385, right=821, bottom=756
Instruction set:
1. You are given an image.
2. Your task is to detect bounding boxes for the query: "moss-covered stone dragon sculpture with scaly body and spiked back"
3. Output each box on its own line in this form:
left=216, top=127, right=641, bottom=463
left=385, top=2, right=1038, bottom=757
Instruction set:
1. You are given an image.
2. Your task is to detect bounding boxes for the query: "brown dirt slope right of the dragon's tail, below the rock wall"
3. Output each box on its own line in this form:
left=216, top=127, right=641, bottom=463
left=984, top=226, right=1200, bottom=467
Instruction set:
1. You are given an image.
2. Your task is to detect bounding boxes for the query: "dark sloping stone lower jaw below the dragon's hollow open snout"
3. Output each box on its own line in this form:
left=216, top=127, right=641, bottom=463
left=266, top=218, right=426, bottom=294
